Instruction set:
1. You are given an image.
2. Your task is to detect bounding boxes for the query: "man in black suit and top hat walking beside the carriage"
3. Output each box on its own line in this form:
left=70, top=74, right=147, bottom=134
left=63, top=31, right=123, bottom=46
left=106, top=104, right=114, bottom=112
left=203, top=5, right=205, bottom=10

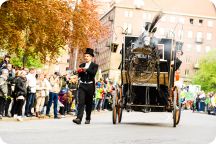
left=73, top=48, right=98, bottom=124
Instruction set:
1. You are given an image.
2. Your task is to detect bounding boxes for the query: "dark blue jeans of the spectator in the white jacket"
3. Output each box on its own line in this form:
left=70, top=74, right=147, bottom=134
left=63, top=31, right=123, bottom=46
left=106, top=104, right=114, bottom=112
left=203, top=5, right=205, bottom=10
left=25, top=93, right=36, bottom=115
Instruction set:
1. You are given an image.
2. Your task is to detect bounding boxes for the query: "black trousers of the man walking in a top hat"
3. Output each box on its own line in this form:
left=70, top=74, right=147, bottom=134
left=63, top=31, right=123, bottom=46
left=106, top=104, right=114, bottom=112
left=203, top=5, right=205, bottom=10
left=77, top=83, right=95, bottom=120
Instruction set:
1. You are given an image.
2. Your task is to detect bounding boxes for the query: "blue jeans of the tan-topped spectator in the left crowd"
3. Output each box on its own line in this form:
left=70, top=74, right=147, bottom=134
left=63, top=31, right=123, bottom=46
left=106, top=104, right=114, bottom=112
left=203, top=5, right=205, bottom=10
left=46, top=92, right=58, bottom=117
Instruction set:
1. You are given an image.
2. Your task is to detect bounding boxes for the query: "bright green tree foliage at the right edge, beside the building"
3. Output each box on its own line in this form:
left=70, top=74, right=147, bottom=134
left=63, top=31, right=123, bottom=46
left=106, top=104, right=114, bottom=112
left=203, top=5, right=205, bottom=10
left=193, top=51, right=216, bottom=92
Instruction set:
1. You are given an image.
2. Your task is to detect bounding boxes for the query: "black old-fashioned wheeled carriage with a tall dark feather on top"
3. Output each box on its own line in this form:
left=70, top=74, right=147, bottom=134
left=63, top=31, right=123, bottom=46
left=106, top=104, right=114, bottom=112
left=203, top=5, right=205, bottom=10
left=112, top=14, right=183, bottom=127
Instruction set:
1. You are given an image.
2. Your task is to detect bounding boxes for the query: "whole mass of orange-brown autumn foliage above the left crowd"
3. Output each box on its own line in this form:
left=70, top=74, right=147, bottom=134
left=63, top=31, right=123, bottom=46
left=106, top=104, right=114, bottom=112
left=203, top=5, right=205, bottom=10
left=0, top=0, right=106, bottom=67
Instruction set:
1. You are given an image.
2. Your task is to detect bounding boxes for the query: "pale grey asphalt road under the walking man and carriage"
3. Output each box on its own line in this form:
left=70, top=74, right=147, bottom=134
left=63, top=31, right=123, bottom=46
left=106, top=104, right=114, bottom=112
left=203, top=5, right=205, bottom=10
left=0, top=111, right=216, bottom=144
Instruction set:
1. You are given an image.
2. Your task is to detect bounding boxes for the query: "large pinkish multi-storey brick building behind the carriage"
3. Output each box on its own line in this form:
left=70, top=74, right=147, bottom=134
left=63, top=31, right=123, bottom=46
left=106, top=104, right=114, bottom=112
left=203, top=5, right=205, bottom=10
left=95, top=0, right=216, bottom=81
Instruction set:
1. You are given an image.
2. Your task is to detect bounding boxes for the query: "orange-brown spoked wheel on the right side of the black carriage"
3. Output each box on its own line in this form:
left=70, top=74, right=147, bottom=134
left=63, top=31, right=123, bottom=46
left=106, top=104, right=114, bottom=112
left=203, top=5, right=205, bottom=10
left=173, top=87, right=181, bottom=127
